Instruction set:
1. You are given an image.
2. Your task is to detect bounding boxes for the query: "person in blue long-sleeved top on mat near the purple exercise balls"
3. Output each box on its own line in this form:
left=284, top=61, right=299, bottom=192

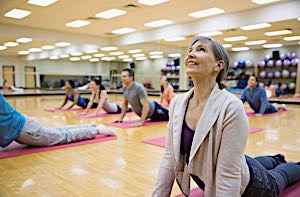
left=240, top=75, right=286, bottom=116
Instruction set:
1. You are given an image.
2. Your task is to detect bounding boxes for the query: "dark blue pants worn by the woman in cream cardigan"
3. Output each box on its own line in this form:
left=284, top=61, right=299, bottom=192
left=242, top=155, right=300, bottom=197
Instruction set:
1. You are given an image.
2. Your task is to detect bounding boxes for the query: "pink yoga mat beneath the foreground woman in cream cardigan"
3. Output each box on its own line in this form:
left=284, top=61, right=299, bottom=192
left=176, top=181, right=300, bottom=197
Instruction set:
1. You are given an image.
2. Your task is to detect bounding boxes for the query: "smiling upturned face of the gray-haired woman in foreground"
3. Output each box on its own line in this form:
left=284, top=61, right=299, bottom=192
left=185, top=41, right=218, bottom=77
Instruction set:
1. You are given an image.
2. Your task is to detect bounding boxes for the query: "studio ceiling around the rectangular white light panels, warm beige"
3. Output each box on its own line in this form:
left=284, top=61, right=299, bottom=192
left=0, top=0, right=300, bottom=60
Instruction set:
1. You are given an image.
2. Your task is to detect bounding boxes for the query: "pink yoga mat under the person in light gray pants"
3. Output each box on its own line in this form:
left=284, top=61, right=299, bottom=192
left=0, top=134, right=117, bottom=159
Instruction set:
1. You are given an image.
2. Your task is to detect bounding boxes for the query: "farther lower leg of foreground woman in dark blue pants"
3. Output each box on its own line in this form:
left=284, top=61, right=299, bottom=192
left=253, top=154, right=286, bottom=170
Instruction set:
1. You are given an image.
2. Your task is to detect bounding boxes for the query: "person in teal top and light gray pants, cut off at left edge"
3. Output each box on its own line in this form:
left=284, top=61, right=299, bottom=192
left=0, top=94, right=115, bottom=147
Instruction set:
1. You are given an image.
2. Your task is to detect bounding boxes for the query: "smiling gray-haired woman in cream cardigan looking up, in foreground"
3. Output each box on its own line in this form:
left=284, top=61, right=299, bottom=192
left=152, top=36, right=300, bottom=197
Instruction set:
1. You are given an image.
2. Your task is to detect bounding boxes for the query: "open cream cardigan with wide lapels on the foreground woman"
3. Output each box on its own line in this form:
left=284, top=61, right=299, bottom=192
left=152, top=84, right=250, bottom=197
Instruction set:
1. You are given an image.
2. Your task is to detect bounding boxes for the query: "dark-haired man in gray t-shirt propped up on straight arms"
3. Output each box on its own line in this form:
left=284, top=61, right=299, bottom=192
left=115, top=68, right=169, bottom=126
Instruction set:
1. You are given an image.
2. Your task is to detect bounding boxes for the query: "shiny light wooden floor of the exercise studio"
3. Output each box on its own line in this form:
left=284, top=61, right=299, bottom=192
left=0, top=95, right=300, bottom=197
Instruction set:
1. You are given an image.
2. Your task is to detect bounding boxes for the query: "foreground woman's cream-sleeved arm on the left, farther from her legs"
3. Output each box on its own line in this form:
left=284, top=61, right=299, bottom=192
left=152, top=97, right=175, bottom=197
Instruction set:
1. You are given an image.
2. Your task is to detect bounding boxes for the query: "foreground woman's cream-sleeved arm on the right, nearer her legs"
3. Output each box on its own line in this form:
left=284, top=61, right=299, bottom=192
left=216, top=102, right=249, bottom=197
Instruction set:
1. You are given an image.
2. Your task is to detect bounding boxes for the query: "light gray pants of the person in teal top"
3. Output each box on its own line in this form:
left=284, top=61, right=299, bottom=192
left=16, top=117, right=97, bottom=146
